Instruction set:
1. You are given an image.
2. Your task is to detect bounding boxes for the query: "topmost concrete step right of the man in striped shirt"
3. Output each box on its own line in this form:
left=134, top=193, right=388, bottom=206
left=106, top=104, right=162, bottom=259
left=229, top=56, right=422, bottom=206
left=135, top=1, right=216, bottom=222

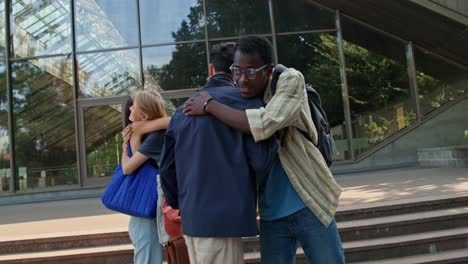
left=335, top=194, right=468, bottom=222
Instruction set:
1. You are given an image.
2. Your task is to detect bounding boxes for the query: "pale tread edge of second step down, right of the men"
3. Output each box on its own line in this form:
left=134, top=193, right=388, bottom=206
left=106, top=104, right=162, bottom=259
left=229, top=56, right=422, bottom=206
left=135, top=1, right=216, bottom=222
left=337, top=206, right=468, bottom=232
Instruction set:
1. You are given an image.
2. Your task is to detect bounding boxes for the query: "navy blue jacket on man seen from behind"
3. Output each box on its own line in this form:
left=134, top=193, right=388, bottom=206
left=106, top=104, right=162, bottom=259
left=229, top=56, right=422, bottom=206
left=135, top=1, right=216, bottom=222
left=160, top=75, right=277, bottom=237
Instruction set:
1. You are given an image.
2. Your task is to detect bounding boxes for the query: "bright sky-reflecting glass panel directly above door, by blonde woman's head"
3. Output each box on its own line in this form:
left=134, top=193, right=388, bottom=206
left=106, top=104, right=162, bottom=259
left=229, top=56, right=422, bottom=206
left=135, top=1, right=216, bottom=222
left=77, top=49, right=141, bottom=98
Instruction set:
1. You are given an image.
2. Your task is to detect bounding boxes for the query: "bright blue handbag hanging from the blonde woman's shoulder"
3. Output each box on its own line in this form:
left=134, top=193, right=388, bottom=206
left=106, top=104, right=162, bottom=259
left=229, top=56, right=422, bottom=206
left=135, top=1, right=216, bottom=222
left=101, top=145, right=159, bottom=218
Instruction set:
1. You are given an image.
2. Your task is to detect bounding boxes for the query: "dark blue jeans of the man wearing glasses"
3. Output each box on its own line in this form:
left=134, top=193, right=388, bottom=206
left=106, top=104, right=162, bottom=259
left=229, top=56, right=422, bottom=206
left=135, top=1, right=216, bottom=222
left=260, top=207, right=345, bottom=264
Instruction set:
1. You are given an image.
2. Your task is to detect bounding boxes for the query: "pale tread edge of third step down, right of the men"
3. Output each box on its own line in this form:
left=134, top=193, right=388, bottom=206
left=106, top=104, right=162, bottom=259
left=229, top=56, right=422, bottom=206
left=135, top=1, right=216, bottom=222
left=343, top=227, right=468, bottom=252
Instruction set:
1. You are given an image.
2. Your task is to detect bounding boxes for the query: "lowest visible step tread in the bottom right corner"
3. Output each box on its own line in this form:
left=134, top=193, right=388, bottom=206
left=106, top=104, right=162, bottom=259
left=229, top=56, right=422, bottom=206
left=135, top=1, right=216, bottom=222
left=353, top=249, right=468, bottom=264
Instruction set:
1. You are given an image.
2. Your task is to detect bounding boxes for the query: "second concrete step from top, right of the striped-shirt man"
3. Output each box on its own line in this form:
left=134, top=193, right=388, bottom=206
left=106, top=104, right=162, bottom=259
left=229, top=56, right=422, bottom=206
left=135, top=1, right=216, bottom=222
left=338, top=206, right=468, bottom=242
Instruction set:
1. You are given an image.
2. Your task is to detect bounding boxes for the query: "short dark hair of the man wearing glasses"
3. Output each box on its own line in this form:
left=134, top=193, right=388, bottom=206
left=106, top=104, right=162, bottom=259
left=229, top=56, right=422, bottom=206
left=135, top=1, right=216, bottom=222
left=236, top=35, right=273, bottom=64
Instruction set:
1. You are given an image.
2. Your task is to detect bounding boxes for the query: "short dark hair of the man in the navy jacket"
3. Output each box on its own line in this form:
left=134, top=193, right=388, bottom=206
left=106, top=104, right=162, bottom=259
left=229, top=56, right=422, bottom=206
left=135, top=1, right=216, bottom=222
left=210, top=42, right=236, bottom=73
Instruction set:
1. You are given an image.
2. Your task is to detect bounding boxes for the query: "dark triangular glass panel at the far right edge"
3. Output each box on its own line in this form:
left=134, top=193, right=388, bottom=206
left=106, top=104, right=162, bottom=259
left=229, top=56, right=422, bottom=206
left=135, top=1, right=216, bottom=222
left=414, top=48, right=468, bottom=115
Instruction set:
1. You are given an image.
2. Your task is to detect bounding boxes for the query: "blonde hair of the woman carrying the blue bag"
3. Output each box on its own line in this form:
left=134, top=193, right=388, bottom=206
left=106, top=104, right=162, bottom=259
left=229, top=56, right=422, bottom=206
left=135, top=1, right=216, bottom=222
left=132, top=90, right=167, bottom=120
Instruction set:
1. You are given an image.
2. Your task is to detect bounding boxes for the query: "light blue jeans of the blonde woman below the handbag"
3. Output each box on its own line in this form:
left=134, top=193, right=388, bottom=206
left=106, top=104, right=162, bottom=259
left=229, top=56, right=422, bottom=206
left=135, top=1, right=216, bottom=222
left=128, top=216, right=162, bottom=264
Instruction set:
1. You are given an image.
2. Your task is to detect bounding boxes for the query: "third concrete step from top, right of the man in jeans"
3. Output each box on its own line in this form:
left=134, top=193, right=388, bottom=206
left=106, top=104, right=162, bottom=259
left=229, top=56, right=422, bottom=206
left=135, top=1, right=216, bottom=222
left=343, top=227, right=468, bottom=263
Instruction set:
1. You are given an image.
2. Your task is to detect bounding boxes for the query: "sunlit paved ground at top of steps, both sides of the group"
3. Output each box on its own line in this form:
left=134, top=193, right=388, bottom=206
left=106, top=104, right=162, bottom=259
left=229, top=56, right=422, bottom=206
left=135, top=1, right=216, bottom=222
left=0, top=168, right=468, bottom=241
